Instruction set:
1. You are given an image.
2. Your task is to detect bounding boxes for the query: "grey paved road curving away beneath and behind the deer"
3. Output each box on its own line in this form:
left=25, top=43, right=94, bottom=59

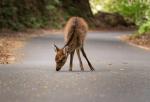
left=0, top=32, right=150, bottom=102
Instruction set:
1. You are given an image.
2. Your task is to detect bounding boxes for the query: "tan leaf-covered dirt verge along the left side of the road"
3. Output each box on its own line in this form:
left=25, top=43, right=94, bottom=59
left=0, top=29, right=62, bottom=64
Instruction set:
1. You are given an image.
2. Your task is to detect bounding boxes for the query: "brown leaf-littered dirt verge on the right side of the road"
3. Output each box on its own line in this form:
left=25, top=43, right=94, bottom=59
left=119, top=34, right=150, bottom=50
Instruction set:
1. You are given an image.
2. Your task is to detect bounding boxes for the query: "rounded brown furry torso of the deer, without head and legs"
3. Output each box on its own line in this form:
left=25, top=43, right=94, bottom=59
left=64, top=17, right=88, bottom=52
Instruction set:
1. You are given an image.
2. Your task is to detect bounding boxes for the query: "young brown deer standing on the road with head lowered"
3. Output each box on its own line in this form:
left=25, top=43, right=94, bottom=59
left=54, top=17, right=94, bottom=71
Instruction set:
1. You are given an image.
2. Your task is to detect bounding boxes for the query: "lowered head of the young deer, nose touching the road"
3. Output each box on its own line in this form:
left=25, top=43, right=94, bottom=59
left=54, top=44, right=68, bottom=71
